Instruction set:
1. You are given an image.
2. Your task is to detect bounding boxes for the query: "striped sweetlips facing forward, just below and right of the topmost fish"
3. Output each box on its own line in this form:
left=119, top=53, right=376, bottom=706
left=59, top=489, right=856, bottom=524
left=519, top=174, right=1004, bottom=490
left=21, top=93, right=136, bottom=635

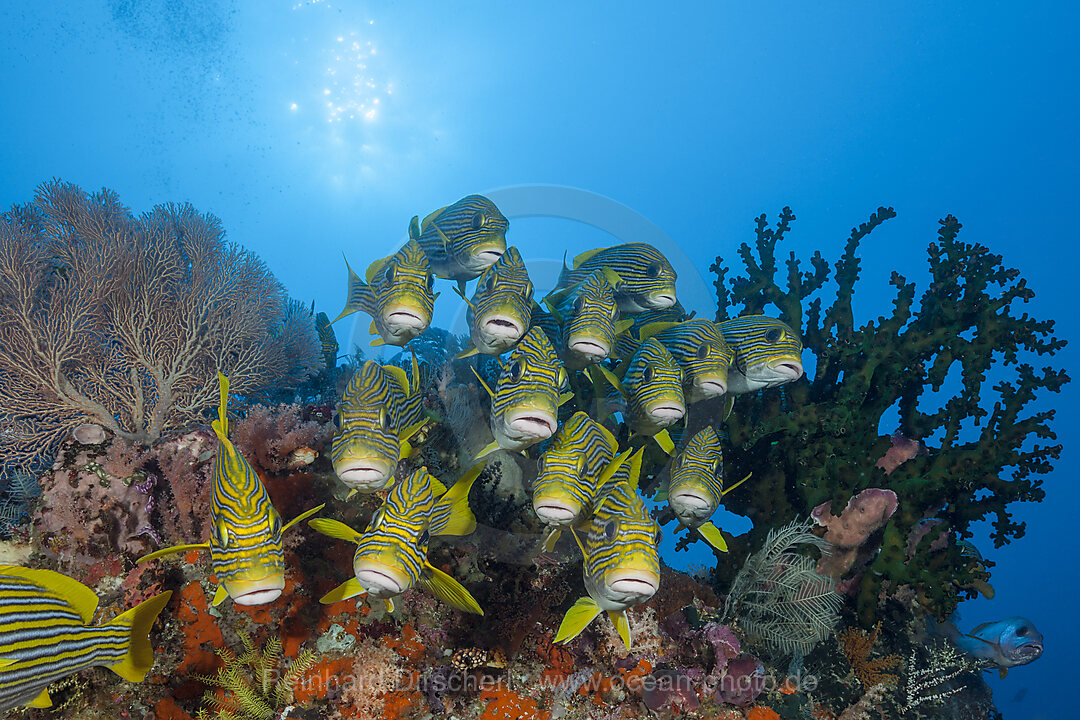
left=458, top=247, right=535, bottom=357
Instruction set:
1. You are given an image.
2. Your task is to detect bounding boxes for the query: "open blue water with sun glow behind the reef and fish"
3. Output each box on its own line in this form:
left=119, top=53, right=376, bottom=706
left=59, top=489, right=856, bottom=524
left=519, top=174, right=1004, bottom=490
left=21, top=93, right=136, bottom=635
left=0, top=0, right=1080, bottom=720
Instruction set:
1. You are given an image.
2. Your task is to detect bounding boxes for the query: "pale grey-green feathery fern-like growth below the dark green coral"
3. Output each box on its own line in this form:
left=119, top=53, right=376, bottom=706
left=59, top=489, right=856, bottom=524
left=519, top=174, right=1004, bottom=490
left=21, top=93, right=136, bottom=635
left=724, top=519, right=842, bottom=655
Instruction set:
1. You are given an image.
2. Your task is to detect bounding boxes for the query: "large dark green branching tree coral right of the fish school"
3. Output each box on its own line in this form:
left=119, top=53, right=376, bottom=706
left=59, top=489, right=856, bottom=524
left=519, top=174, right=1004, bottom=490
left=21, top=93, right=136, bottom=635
left=704, top=207, right=1068, bottom=625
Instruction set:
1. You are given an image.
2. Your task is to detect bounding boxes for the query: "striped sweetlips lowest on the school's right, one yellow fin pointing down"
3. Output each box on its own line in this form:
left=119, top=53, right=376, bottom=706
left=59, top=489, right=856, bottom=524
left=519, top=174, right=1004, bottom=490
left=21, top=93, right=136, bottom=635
left=654, top=425, right=748, bottom=553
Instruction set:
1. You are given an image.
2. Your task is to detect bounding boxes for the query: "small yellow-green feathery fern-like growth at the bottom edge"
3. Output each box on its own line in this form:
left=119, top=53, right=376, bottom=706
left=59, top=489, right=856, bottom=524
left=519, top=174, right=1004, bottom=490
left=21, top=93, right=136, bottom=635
left=195, top=633, right=315, bottom=720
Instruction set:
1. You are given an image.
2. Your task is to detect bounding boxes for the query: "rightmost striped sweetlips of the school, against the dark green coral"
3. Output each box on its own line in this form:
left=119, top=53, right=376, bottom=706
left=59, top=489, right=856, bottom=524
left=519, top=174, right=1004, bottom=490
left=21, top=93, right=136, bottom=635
left=717, top=315, right=802, bottom=394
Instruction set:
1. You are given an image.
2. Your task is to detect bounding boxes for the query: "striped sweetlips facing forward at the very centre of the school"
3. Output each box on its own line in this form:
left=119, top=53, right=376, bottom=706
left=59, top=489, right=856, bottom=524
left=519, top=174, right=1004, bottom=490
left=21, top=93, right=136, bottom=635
left=473, top=327, right=571, bottom=458
